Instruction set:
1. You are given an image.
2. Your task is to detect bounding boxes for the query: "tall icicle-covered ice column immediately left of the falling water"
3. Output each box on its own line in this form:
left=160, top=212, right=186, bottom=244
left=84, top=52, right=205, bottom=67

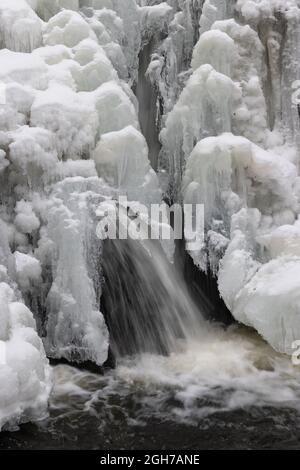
left=36, top=177, right=111, bottom=365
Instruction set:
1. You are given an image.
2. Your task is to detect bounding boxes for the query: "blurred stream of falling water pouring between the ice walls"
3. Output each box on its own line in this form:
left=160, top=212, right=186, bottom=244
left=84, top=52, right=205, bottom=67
left=102, top=240, right=204, bottom=357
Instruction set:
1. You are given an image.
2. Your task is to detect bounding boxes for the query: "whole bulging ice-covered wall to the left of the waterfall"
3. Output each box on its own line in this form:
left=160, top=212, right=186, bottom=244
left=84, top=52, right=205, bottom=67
left=0, top=0, right=164, bottom=428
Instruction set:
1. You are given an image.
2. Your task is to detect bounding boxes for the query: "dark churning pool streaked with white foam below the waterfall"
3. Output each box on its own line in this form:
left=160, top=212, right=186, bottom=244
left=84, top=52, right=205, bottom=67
left=0, top=326, right=300, bottom=449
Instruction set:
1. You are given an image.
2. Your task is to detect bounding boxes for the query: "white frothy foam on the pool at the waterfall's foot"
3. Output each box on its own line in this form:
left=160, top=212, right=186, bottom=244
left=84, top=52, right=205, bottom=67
left=51, top=326, right=300, bottom=427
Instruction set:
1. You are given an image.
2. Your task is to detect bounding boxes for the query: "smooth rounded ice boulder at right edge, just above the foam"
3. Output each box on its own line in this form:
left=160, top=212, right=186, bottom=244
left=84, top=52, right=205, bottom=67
left=233, top=256, right=300, bottom=354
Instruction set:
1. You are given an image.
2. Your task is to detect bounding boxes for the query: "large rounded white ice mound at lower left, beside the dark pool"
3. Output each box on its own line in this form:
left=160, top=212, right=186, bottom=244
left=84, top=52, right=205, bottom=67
left=0, top=283, right=51, bottom=430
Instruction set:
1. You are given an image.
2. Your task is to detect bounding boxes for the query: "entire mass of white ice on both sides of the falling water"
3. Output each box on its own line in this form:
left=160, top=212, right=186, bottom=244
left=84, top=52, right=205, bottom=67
left=0, top=0, right=300, bottom=428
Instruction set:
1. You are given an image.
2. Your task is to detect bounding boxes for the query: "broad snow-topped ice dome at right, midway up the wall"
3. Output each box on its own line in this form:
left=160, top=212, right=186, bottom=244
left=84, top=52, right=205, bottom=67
left=183, top=133, right=299, bottom=232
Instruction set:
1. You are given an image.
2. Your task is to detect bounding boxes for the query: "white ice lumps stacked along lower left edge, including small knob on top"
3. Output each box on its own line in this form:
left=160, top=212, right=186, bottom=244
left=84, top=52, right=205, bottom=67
left=0, top=226, right=51, bottom=429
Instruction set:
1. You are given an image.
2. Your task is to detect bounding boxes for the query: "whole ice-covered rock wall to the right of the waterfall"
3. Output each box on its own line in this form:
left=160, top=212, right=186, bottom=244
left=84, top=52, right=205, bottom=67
left=157, top=0, right=300, bottom=353
